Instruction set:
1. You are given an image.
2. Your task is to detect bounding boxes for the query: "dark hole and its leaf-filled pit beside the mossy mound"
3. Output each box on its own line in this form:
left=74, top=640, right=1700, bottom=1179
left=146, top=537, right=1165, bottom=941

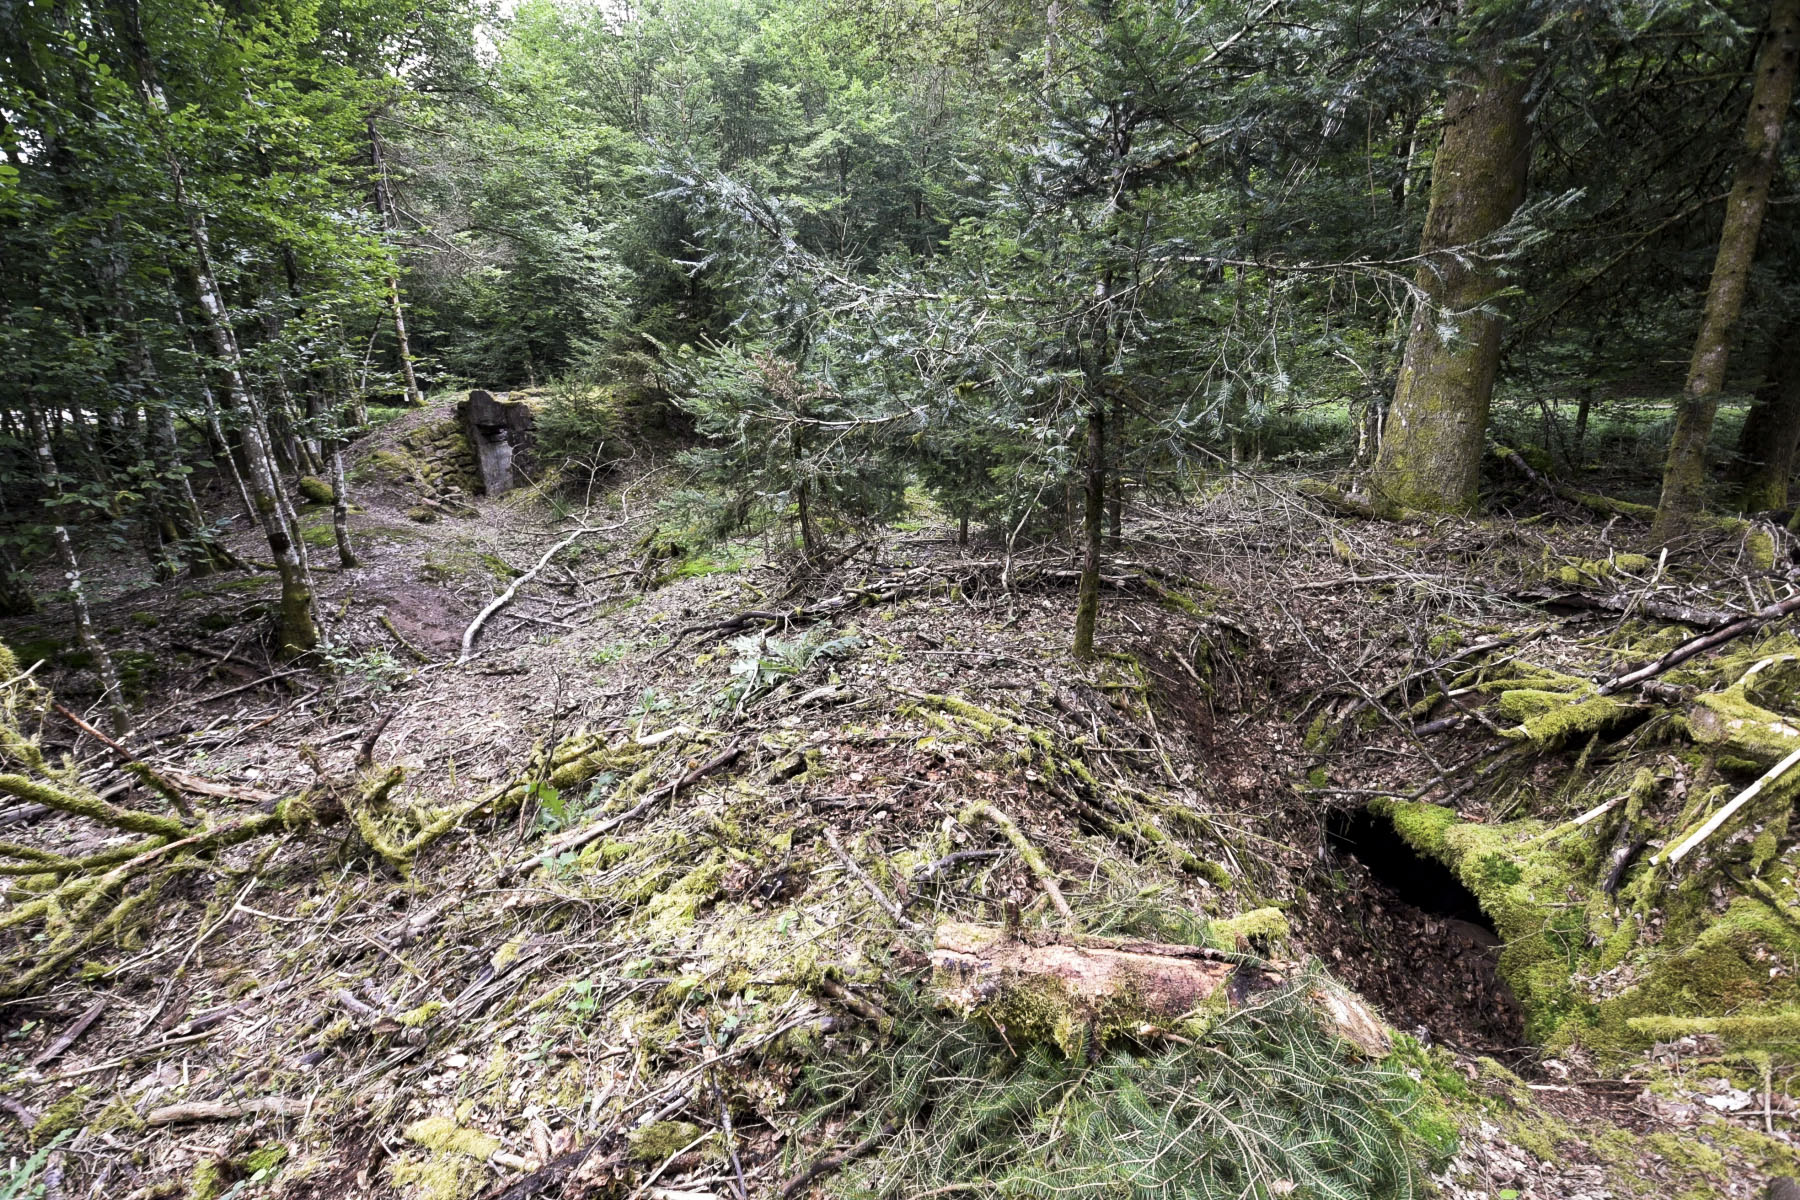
left=1318, top=810, right=1525, bottom=1054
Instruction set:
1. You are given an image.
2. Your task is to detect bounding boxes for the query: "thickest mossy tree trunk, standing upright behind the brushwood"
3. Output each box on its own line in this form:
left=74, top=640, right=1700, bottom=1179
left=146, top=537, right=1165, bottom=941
left=1373, top=63, right=1530, bottom=511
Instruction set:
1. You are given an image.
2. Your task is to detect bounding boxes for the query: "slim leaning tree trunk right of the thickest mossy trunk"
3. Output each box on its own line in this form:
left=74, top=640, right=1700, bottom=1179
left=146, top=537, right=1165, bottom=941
left=1652, top=0, right=1800, bottom=542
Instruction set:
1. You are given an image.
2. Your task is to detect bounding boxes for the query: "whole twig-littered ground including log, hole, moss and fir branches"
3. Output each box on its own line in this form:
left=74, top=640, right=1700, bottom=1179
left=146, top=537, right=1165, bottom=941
left=0, top=414, right=1800, bottom=1200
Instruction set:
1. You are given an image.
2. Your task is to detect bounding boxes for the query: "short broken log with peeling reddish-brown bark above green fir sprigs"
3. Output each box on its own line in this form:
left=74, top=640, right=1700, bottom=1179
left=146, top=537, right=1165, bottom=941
left=931, top=923, right=1391, bottom=1058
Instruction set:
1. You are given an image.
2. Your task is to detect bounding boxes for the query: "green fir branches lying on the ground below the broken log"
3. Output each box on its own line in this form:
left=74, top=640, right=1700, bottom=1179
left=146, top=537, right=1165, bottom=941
left=803, top=973, right=1442, bottom=1200
